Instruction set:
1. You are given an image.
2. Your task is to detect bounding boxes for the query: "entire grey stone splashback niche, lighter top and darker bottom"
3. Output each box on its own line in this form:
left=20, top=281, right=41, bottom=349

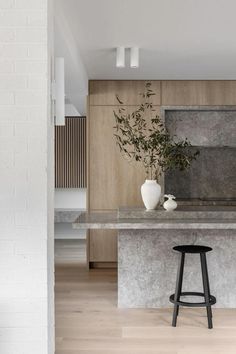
left=164, top=107, right=236, bottom=201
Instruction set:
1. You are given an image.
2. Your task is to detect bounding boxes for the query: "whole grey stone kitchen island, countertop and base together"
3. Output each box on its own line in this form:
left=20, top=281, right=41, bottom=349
left=73, top=206, right=236, bottom=308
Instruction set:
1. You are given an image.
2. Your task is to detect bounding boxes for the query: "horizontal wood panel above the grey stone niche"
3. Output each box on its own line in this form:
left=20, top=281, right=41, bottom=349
left=162, top=80, right=236, bottom=106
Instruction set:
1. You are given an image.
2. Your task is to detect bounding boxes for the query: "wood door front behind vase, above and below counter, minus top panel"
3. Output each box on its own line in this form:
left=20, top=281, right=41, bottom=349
left=89, top=106, right=151, bottom=262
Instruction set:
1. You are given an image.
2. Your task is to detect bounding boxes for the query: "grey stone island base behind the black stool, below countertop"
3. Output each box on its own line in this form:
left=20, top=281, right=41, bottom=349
left=118, top=229, right=236, bottom=308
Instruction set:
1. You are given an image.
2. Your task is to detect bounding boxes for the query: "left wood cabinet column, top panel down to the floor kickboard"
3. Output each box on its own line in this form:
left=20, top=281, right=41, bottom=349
left=88, top=81, right=160, bottom=266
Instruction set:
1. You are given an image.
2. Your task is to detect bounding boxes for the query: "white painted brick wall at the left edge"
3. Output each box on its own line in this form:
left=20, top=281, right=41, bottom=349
left=0, top=0, right=54, bottom=354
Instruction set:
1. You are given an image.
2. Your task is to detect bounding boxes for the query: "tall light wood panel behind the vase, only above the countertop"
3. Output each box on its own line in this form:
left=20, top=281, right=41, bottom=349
left=89, top=106, right=150, bottom=209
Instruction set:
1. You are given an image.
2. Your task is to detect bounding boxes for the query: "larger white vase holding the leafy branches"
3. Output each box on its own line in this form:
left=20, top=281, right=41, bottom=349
left=141, top=179, right=161, bottom=210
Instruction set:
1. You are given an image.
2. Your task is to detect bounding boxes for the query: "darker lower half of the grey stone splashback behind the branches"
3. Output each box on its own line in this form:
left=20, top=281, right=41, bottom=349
left=165, top=147, right=236, bottom=200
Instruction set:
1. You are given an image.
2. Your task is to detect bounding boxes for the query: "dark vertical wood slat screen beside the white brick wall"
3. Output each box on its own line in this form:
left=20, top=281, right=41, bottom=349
left=55, top=117, right=87, bottom=188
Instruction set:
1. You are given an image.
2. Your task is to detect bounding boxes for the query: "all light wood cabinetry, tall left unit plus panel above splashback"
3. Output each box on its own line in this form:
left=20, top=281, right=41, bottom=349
left=87, top=80, right=236, bottom=267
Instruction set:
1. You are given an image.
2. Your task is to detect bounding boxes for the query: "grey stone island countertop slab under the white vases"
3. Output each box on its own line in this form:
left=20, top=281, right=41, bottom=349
left=73, top=206, right=236, bottom=230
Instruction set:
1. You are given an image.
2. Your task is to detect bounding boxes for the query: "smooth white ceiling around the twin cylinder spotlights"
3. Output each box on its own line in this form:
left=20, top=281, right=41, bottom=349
left=55, top=0, right=236, bottom=113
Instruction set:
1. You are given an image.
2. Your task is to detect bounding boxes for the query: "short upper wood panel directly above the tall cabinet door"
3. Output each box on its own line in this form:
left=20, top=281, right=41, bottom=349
left=89, top=80, right=160, bottom=106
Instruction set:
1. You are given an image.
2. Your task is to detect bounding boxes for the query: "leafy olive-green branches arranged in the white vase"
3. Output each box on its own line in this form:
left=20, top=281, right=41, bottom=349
left=113, top=82, right=199, bottom=180
